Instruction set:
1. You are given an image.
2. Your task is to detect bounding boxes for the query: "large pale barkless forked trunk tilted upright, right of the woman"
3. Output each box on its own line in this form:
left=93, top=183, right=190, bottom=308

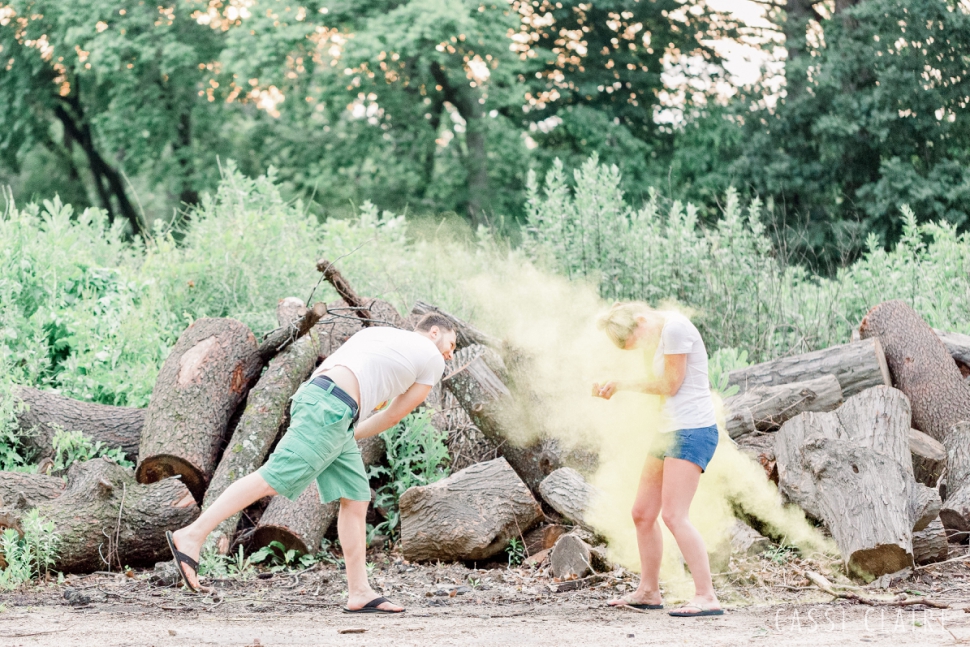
left=775, top=387, right=939, bottom=576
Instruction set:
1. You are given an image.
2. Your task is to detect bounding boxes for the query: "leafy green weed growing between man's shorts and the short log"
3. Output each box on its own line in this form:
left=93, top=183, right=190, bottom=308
left=367, top=408, right=449, bottom=537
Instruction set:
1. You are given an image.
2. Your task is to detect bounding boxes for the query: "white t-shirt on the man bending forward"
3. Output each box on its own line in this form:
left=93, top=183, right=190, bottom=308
left=313, top=327, right=445, bottom=420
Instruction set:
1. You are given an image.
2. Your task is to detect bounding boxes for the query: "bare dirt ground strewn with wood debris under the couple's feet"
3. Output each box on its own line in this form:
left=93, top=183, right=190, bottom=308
left=0, top=557, right=970, bottom=647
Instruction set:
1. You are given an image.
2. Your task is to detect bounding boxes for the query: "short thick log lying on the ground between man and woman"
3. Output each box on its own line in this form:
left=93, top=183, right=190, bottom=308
left=399, top=458, right=542, bottom=561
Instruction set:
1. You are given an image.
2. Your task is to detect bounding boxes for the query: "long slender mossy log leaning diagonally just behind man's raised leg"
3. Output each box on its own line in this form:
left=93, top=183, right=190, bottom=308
left=202, top=331, right=320, bottom=555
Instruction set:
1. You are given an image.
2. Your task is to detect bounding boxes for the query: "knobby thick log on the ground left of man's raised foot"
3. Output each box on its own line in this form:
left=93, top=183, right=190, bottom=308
left=37, top=458, right=199, bottom=573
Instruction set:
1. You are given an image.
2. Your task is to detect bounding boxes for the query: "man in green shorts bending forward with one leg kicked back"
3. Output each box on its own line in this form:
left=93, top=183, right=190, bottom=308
left=166, top=313, right=456, bottom=613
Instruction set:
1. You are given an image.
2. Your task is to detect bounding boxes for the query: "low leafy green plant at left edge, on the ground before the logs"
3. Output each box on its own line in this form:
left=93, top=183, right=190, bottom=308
left=0, top=510, right=60, bottom=590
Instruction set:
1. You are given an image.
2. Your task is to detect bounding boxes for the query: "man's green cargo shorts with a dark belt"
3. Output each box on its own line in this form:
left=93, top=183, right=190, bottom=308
left=258, top=383, right=370, bottom=503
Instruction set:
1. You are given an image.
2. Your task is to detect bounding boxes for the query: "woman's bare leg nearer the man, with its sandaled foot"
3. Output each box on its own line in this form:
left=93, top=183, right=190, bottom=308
left=608, top=456, right=664, bottom=606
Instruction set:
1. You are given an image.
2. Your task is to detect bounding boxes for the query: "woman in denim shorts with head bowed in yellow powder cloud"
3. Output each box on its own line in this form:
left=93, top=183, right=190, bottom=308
left=593, top=303, right=724, bottom=617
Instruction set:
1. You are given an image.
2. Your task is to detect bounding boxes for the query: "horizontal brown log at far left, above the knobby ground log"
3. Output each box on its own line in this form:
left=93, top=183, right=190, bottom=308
left=14, top=386, right=145, bottom=460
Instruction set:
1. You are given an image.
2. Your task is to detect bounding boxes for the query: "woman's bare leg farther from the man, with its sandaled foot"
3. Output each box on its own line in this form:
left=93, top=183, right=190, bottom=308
left=661, top=457, right=721, bottom=611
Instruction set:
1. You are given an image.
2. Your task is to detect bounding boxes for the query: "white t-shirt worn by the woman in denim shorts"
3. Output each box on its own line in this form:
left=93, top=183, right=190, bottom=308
left=653, top=312, right=717, bottom=431
